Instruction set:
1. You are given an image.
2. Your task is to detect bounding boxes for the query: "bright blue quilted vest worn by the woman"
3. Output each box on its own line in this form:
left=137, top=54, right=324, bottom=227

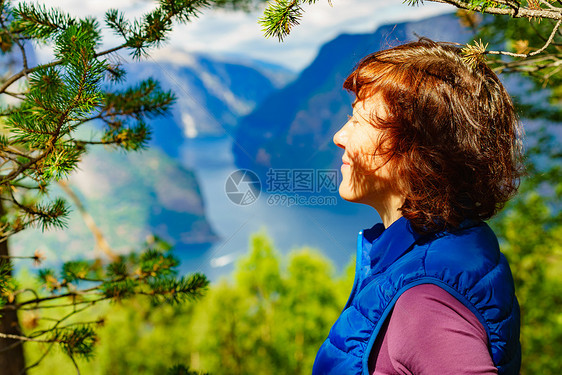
left=312, top=217, right=521, bottom=375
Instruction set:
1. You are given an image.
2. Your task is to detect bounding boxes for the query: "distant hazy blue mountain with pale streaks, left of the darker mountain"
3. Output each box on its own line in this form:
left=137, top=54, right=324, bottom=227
left=118, top=50, right=294, bottom=158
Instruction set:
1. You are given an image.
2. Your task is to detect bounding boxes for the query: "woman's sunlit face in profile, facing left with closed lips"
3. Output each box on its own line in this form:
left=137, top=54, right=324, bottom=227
left=334, top=96, right=398, bottom=213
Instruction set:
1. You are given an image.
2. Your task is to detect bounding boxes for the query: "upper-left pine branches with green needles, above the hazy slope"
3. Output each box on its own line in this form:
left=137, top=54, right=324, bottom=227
left=0, top=0, right=228, bottom=236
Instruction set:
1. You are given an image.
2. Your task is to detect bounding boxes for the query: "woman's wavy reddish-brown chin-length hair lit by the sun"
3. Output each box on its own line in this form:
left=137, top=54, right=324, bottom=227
left=343, top=39, right=522, bottom=233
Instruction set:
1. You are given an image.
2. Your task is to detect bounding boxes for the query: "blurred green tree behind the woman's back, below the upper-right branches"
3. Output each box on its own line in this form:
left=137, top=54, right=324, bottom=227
left=493, top=101, right=562, bottom=375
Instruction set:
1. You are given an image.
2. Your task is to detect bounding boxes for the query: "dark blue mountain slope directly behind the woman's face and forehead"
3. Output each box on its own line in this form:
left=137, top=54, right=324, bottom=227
left=233, top=14, right=471, bottom=179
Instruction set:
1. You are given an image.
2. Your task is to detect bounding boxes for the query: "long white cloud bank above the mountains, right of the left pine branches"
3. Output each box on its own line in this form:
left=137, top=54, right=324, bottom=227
left=158, top=0, right=453, bottom=70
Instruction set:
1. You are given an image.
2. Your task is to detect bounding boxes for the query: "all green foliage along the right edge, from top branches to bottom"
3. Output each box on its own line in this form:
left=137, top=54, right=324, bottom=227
left=477, top=13, right=562, bottom=375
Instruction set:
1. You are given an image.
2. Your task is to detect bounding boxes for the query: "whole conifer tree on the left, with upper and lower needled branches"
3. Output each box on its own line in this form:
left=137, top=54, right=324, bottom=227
left=0, top=0, right=251, bottom=375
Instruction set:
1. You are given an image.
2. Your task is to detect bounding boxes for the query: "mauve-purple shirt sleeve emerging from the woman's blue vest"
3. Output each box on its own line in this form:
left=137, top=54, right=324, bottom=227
left=369, top=284, right=497, bottom=375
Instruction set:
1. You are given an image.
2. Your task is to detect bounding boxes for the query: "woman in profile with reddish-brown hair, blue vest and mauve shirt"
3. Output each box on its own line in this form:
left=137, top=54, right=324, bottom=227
left=313, top=40, right=521, bottom=375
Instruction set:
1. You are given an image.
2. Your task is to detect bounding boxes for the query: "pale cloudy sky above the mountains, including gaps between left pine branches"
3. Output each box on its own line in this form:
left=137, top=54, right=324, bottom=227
left=30, top=0, right=454, bottom=71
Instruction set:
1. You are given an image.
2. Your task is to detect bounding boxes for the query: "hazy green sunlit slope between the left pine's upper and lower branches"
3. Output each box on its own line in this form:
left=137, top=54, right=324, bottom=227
left=11, top=142, right=218, bottom=260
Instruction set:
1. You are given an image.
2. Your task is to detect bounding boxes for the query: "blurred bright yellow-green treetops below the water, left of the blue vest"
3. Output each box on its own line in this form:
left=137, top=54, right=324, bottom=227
left=23, top=234, right=353, bottom=375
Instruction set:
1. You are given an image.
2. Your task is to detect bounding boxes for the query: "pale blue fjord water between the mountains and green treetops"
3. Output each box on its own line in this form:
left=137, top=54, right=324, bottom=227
left=175, top=138, right=380, bottom=280
